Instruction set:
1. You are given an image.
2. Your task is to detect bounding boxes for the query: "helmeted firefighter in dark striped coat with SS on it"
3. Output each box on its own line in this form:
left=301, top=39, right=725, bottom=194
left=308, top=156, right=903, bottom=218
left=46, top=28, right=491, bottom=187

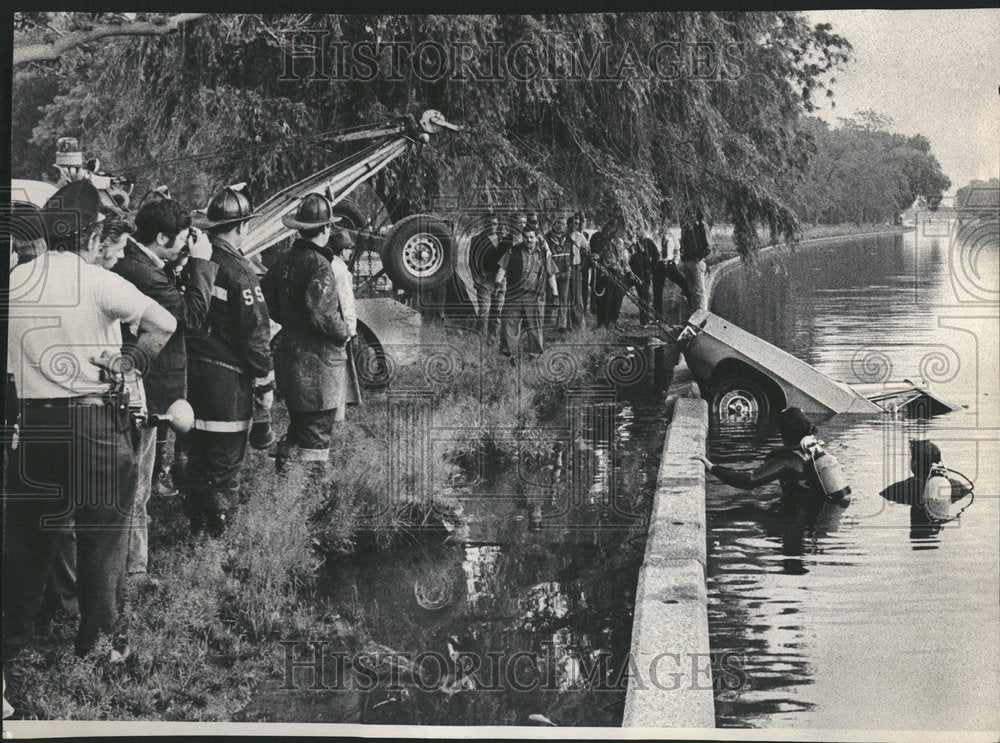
left=184, top=187, right=273, bottom=536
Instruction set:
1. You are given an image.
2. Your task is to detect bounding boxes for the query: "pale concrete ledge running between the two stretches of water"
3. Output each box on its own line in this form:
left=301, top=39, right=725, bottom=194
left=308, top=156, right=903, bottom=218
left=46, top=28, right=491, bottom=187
left=622, top=398, right=715, bottom=728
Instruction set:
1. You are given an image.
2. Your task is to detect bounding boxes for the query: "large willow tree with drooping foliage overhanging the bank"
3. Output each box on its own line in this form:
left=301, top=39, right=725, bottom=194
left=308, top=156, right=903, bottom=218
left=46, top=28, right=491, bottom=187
left=15, top=12, right=850, bottom=255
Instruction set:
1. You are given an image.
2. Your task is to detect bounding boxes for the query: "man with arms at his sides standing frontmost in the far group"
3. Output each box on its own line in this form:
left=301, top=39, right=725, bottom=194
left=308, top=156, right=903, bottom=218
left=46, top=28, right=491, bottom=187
left=496, top=226, right=559, bottom=364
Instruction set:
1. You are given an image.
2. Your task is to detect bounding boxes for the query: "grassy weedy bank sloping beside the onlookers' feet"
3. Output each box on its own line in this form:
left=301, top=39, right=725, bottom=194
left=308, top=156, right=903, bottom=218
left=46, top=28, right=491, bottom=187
left=6, top=326, right=632, bottom=721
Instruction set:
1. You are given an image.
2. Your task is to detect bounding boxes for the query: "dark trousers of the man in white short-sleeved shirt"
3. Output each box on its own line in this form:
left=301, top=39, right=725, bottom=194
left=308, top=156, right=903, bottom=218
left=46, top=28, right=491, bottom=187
left=3, top=401, right=136, bottom=659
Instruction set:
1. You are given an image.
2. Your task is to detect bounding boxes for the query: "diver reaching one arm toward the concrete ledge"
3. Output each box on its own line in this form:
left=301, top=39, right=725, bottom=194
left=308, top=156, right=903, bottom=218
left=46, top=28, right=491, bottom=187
left=696, top=408, right=851, bottom=507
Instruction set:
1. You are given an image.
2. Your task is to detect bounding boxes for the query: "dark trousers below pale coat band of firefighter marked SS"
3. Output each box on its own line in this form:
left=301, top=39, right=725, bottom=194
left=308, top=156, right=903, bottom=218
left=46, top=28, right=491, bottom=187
left=184, top=429, right=248, bottom=521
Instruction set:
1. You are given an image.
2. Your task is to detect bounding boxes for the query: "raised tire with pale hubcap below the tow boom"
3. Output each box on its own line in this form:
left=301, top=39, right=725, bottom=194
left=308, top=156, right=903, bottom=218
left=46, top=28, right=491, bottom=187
left=381, top=214, right=458, bottom=292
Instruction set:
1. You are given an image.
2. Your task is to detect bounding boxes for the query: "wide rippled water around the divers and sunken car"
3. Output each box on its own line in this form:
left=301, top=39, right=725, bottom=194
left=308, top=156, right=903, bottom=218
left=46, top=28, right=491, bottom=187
left=707, top=232, right=1000, bottom=730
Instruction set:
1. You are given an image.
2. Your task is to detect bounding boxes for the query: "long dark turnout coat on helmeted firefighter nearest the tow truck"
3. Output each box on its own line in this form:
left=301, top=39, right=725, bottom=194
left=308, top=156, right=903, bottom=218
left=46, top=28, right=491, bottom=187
left=262, top=239, right=350, bottom=412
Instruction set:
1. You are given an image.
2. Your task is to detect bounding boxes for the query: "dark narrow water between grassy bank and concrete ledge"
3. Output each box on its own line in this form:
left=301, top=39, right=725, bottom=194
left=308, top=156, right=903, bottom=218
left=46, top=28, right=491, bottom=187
left=248, top=344, right=672, bottom=726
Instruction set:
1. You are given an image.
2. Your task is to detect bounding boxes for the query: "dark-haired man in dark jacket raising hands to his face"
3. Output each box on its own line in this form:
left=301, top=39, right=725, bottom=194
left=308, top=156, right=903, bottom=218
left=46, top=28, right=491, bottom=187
left=113, top=199, right=218, bottom=583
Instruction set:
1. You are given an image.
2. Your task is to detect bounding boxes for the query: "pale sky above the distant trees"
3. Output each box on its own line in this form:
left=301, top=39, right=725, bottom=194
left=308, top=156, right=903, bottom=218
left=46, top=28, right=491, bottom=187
left=806, top=9, right=1000, bottom=190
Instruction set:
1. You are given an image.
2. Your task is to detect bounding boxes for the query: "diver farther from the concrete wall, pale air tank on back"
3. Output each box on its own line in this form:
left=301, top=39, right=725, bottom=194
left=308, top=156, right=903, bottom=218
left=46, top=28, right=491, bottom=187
left=880, top=440, right=974, bottom=539
